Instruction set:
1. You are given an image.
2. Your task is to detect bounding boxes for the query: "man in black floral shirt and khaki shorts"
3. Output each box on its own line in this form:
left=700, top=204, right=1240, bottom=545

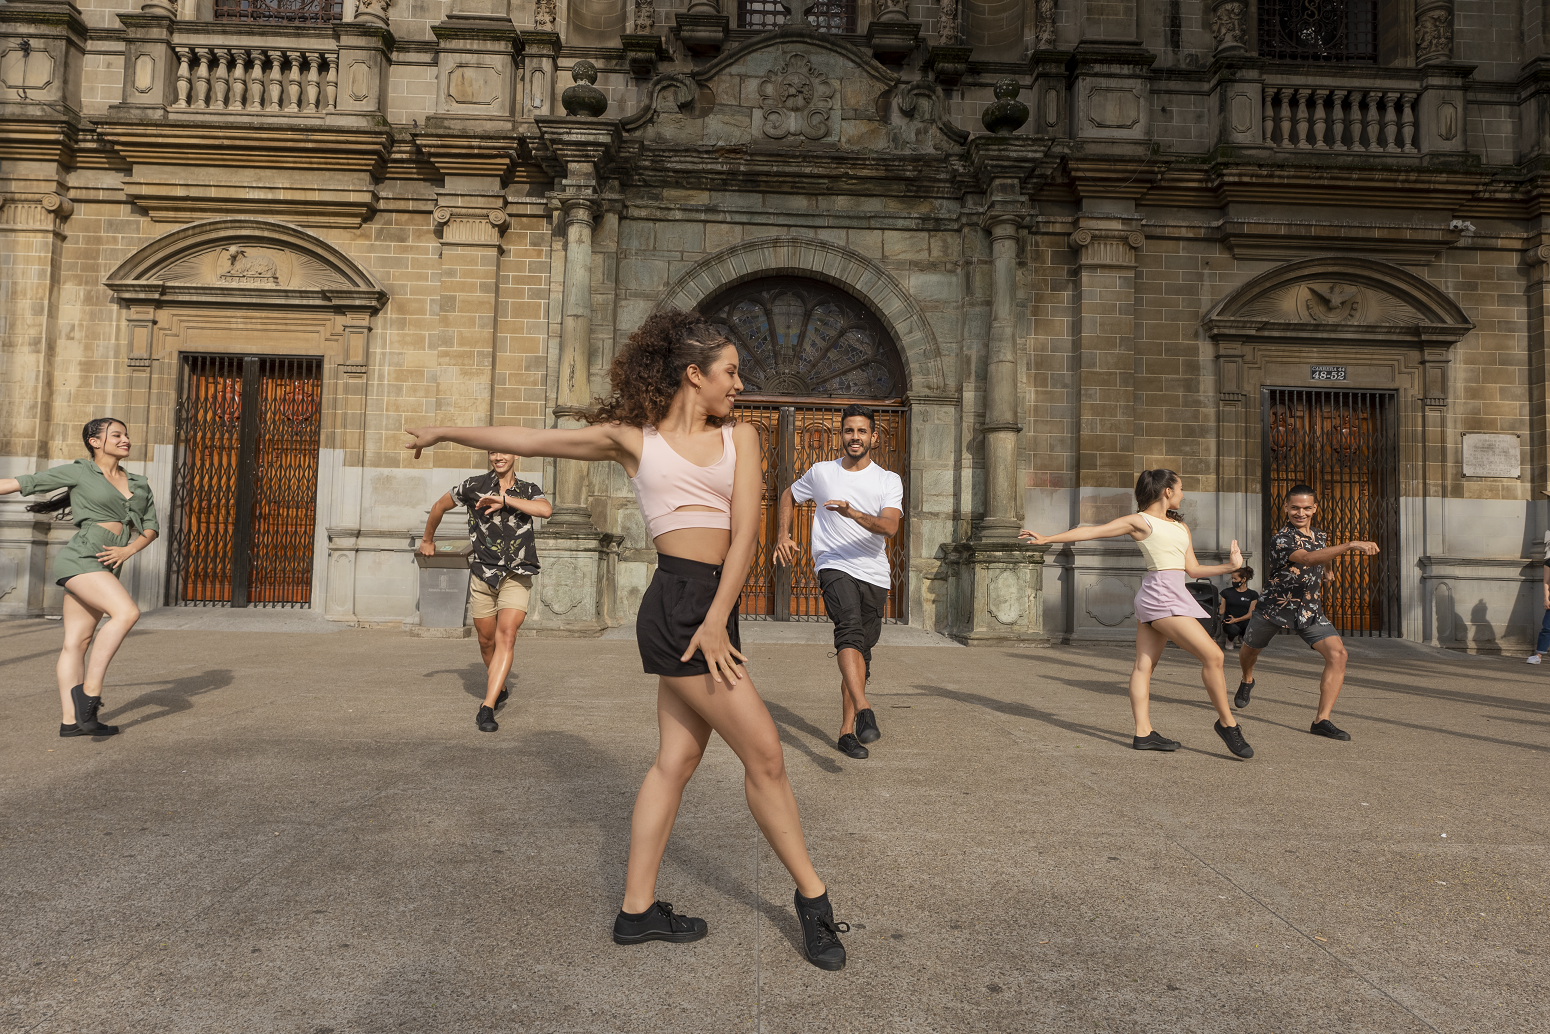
left=420, top=453, right=555, bottom=732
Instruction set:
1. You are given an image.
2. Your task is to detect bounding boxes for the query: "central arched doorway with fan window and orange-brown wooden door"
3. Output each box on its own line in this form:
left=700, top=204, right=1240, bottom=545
left=699, top=276, right=910, bottom=622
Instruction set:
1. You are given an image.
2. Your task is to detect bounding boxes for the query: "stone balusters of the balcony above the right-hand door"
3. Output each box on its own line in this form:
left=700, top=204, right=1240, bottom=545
left=1263, top=82, right=1420, bottom=155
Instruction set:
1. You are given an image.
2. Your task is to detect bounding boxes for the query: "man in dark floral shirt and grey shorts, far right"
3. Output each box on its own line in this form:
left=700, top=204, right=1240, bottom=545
left=1232, top=485, right=1378, bottom=739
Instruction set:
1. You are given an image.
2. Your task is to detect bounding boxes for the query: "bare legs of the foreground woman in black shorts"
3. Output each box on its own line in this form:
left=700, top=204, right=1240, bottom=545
left=623, top=670, right=825, bottom=913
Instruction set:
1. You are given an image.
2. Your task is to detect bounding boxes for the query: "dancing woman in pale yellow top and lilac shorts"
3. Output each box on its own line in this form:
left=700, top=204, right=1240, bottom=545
left=1021, top=470, right=1254, bottom=758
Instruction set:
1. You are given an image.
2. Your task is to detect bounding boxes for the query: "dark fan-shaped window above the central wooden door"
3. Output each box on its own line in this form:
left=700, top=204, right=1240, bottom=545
left=701, top=276, right=905, bottom=398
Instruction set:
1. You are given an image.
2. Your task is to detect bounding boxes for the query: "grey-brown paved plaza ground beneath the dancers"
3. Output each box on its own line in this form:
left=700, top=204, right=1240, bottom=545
left=0, top=620, right=1550, bottom=1034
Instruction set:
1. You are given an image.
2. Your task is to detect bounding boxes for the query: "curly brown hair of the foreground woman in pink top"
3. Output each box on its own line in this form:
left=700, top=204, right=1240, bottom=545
left=586, top=308, right=732, bottom=428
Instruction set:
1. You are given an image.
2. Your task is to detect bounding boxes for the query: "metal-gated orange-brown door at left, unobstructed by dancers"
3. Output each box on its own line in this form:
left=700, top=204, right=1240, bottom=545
left=167, top=355, right=322, bottom=606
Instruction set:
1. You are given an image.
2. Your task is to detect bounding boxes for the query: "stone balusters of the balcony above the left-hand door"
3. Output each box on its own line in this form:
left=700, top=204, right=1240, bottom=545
left=172, top=40, right=339, bottom=115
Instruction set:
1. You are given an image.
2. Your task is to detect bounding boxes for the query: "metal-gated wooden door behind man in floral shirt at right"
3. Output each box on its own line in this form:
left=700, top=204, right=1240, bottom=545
left=1260, top=388, right=1401, bottom=636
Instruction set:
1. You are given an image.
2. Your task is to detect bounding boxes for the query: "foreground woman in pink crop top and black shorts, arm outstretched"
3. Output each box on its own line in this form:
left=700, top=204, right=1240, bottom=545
left=405, top=310, right=849, bottom=969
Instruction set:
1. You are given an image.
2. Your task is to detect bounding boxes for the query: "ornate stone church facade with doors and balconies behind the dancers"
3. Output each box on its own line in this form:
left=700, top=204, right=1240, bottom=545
left=0, top=0, right=1550, bottom=650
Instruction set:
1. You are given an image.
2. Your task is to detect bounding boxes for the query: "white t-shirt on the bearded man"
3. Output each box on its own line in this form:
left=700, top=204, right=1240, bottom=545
left=791, top=459, right=904, bottom=589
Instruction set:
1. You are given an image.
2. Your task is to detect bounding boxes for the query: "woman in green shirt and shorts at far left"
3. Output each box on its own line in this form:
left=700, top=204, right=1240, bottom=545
left=0, top=417, right=160, bottom=736
